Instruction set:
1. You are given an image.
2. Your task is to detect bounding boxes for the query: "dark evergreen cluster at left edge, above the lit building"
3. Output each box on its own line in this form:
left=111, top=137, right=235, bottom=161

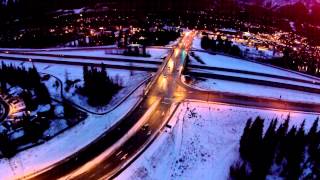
left=0, top=62, right=51, bottom=106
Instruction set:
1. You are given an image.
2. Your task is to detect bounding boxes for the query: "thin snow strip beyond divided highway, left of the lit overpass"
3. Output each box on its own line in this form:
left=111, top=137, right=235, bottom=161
left=31, top=48, right=168, bottom=60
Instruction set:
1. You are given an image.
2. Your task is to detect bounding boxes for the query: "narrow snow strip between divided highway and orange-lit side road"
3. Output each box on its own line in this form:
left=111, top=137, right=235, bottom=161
left=191, top=79, right=320, bottom=103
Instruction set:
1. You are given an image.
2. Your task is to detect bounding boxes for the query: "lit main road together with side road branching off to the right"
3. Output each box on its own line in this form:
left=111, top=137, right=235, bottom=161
left=16, top=32, right=320, bottom=179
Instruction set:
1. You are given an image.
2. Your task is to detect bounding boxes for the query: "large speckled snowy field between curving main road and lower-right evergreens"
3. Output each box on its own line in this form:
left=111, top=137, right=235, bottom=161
left=117, top=102, right=318, bottom=180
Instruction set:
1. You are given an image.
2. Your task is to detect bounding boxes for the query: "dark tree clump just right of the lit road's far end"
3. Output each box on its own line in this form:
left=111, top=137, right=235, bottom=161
left=201, top=34, right=242, bottom=57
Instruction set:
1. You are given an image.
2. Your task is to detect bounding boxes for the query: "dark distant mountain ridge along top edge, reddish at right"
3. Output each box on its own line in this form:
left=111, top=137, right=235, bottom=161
left=0, top=0, right=320, bottom=22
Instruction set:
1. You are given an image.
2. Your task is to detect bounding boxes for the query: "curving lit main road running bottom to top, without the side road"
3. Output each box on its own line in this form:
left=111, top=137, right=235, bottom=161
left=26, top=31, right=193, bottom=179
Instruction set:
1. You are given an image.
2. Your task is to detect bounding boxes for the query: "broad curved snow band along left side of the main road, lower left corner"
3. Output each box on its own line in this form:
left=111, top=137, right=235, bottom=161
left=0, top=82, right=143, bottom=179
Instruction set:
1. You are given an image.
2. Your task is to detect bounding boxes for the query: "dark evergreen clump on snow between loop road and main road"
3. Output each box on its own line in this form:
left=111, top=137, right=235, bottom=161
left=80, top=64, right=122, bottom=106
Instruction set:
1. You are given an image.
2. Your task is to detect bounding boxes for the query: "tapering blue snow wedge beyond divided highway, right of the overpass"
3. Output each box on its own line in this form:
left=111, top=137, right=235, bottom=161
left=191, top=52, right=320, bottom=82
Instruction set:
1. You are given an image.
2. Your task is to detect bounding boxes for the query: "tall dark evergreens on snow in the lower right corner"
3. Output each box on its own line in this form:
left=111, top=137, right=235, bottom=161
left=230, top=116, right=320, bottom=180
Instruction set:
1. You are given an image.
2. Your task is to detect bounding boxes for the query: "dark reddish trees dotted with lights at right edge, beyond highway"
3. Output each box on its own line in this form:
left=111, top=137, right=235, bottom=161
left=269, top=48, right=320, bottom=76
